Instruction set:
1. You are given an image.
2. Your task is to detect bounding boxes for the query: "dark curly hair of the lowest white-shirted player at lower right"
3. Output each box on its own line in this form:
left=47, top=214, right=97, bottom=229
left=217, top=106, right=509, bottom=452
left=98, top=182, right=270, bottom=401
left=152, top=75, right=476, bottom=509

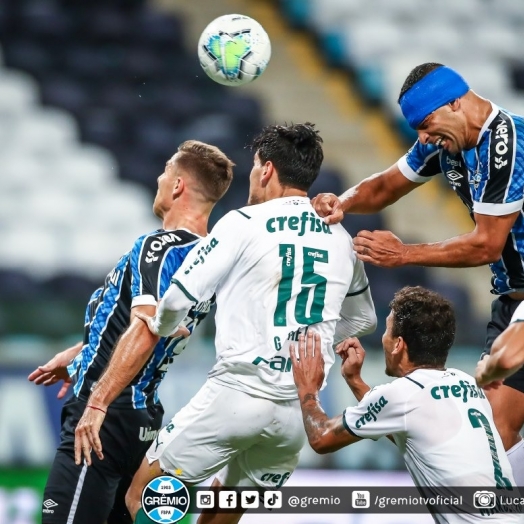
left=389, top=286, right=455, bottom=367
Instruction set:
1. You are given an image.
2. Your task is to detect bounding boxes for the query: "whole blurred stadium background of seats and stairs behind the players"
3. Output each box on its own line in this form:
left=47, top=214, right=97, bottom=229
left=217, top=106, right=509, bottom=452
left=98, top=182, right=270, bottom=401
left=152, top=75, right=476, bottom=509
left=0, top=0, right=524, bottom=524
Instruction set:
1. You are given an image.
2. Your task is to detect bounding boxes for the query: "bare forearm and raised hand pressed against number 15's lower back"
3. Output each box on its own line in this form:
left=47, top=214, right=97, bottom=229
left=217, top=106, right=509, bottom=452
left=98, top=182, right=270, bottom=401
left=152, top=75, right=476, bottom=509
left=289, top=331, right=360, bottom=454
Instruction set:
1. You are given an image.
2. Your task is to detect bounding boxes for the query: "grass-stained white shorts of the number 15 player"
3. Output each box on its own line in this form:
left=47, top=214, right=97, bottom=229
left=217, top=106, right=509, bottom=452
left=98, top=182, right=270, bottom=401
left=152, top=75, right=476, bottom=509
left=146, top=380, right=306, bottom=488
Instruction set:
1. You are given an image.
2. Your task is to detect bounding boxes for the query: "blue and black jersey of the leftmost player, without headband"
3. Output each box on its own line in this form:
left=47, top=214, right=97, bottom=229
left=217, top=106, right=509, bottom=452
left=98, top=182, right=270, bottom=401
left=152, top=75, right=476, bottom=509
left=68, top=229, right=212, bottom=409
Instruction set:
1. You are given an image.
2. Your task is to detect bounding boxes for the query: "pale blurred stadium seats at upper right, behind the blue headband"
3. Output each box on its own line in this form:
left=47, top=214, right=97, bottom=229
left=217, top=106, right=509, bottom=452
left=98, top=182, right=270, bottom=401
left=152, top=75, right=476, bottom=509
left=280, top=0, right=524, bottom=142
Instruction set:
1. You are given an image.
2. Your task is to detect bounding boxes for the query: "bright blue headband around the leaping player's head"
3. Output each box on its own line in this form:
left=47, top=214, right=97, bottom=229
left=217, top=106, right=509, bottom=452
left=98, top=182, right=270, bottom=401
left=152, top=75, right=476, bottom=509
left=399, top=66, right=469, bottom=129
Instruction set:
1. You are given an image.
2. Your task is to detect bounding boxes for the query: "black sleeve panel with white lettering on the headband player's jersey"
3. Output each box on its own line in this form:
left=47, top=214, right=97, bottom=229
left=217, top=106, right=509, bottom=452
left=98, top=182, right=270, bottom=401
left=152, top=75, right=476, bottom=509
left=482, top=111, right=517, bottom=204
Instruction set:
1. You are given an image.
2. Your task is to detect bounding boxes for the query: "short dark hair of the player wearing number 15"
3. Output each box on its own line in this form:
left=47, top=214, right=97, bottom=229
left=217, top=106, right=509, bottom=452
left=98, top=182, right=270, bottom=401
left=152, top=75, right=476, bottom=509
left=251, top=122, right=324, bottom=191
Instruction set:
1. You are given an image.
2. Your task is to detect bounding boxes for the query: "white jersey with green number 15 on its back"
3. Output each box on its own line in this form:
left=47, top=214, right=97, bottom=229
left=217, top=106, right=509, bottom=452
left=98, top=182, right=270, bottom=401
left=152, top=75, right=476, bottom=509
left=174, top=197, right=368, bottom=399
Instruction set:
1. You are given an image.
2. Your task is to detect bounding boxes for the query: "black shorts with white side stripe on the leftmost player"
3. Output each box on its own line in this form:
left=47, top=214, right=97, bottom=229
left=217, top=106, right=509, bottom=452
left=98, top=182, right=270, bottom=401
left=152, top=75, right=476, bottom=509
left=42, top=396, right=164, bottom=524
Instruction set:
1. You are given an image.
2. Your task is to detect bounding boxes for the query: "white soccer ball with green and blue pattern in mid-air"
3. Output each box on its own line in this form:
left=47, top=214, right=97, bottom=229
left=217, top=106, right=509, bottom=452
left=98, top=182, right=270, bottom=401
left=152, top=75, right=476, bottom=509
left=198, top=15, right=271, bottom=86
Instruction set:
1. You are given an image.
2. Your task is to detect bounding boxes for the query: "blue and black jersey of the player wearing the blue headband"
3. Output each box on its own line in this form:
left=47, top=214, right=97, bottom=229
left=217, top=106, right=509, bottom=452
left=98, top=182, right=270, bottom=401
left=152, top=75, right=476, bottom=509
left=398, top=105, right=524, bottom=294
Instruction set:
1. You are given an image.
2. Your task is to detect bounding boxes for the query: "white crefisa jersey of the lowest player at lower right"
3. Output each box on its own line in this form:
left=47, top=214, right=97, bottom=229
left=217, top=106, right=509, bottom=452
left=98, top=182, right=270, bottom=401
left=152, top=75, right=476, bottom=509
left=343, top=368, right=523, bottom=524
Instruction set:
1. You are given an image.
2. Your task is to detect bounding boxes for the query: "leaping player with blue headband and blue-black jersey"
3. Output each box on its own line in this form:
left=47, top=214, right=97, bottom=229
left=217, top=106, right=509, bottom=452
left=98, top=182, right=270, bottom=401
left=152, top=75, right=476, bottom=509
left=313, top=63, right=524, bottom=486
